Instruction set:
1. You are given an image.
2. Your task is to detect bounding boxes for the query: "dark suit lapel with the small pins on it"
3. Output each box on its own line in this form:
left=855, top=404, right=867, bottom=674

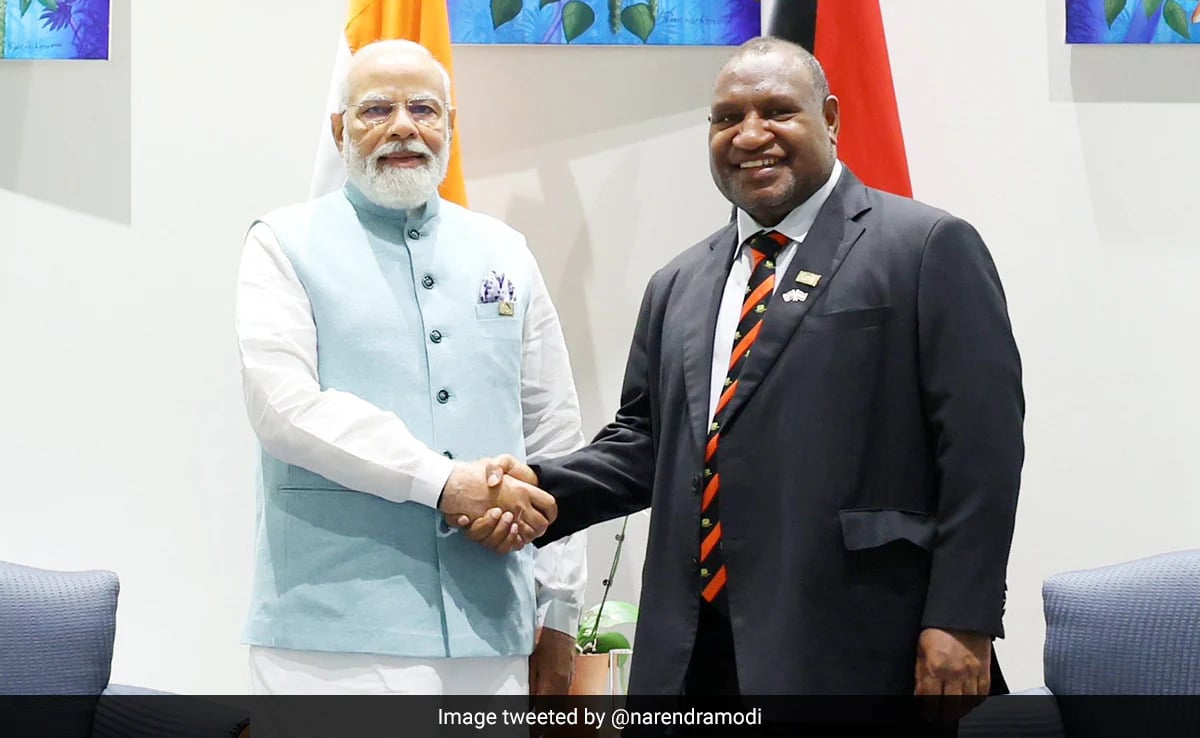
left=725, top=169, right=870, bottom=427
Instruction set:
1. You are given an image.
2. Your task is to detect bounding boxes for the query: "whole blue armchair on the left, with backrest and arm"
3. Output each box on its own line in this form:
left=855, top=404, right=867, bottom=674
left=0, top=562, right=245, bottom=738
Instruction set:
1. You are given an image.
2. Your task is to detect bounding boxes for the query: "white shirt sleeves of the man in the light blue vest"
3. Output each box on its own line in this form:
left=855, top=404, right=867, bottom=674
left=235, top=224, right=587, bottom=650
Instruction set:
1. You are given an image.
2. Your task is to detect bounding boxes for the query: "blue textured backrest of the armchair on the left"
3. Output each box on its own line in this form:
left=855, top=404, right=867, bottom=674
left=0, top=562, right=120, bottom=696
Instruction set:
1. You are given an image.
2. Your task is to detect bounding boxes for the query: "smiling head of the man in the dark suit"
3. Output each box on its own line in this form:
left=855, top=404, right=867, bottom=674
left=708, top=47, right=839, bottom=227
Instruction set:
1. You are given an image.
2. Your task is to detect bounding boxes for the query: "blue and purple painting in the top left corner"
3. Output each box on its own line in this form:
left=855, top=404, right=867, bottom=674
left=0, top=0, right=110, bottom=59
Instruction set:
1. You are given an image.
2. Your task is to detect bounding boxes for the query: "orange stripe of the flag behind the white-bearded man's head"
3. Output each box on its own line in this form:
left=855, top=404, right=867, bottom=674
left=346, top=0, right=467, bottom=208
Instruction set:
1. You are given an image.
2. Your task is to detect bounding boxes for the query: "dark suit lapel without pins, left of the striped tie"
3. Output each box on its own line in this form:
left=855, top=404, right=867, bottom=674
left=680, top=224, right=738, bottom=456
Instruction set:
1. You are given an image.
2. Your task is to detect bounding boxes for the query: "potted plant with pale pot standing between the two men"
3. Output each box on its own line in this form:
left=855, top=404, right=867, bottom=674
left=570, top=517, right=637, bottom=695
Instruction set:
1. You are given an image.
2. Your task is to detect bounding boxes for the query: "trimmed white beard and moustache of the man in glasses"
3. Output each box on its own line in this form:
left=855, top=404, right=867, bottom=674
left=342, top=128, right=450, bottom=210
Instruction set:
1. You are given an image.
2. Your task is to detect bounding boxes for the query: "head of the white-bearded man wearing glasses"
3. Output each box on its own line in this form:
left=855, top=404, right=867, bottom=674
left=332, top=44, right=454, bottom=209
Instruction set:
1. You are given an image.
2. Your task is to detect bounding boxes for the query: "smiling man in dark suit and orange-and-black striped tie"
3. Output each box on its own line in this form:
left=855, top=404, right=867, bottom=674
left=460, top=34, right=1024, bottom=720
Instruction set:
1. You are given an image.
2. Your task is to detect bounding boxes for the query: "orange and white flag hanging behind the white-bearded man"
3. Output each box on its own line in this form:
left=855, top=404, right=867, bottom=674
left=310, top=0, right=467, bottom=206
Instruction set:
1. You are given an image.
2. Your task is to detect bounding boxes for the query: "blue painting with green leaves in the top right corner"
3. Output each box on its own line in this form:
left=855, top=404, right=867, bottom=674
left=1067, top=0, right=1200, bottom=43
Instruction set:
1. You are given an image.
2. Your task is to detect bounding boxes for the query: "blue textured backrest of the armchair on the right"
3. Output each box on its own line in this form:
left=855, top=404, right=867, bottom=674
left=1042, top=550, right=1200, bottom=696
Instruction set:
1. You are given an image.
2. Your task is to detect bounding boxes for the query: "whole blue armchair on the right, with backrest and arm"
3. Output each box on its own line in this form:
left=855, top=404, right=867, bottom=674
left=959, top=550, right=1200, bottom=738
